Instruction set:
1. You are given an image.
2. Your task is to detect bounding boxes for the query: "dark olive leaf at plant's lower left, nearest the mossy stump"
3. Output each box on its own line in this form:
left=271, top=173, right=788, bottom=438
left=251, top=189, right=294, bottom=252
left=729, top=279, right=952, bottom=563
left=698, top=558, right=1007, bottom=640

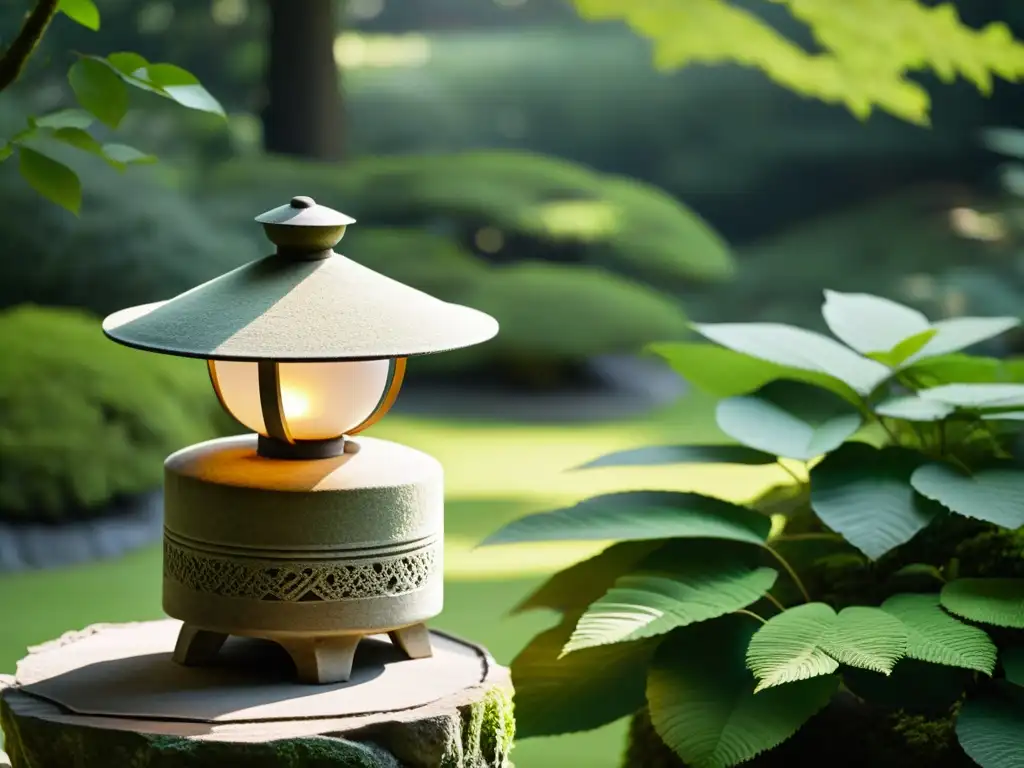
left=511, top=616, right=658, bottom=738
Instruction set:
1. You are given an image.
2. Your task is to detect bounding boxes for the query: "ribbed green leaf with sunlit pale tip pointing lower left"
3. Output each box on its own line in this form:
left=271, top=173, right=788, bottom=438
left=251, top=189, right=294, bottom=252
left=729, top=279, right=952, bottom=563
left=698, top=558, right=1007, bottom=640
left=563, top=541, right=778, bottom=653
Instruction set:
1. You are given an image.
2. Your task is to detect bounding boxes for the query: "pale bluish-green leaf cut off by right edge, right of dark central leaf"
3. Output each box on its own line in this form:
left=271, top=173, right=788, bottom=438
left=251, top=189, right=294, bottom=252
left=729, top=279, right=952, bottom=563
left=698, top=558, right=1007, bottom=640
left=910, top=464, right=1024, bottom=529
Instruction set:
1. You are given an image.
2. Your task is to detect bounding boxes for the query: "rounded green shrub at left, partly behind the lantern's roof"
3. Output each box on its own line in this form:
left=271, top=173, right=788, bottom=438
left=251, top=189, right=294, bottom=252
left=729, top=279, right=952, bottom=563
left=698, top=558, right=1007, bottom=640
left=0, top=305, right=238, bottom=521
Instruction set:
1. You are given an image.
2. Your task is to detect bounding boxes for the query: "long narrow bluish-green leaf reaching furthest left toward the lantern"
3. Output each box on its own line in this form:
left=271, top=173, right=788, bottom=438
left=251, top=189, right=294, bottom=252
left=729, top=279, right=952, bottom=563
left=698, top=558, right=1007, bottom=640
left=480, top=490, right=771, bottom=546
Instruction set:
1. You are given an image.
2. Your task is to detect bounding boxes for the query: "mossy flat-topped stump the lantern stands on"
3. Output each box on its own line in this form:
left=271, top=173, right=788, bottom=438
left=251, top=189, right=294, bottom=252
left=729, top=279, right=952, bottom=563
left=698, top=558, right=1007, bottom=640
left=0, top=621, right=515, bottom=768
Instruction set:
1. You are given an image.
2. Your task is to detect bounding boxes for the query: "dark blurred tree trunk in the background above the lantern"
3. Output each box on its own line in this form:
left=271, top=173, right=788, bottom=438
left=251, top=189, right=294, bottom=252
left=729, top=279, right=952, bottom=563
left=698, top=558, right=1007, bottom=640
left=262, top=0, right=344, bottom=160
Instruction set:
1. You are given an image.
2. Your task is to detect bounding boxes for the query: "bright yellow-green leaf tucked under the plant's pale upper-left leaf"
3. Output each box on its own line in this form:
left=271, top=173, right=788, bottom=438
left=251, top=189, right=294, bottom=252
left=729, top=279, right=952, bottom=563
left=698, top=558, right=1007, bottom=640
left=648, top=342, right=860, bottom=403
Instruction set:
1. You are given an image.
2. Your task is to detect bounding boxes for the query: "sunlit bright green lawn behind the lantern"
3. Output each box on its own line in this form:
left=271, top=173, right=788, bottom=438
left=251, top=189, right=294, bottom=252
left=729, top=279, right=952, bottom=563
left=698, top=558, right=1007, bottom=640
left=0, top=395, right=784, bottom=768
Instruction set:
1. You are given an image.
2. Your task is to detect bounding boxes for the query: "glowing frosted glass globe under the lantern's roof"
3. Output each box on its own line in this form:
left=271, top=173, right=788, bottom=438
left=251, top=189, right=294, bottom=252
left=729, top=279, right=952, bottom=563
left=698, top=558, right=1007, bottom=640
left=211, top=359, right=392, bottom=440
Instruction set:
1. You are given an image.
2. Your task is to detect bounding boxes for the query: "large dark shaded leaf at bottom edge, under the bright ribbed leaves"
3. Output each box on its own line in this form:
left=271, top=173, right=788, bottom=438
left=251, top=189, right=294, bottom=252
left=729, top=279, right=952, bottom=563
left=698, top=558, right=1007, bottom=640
left=647, top=616, right=839, bottom=768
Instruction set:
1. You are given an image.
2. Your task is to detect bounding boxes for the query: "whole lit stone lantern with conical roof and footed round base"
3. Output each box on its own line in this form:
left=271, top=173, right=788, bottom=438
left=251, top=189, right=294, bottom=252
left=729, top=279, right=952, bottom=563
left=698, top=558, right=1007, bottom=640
left=103, top=197, right=498, bottom=683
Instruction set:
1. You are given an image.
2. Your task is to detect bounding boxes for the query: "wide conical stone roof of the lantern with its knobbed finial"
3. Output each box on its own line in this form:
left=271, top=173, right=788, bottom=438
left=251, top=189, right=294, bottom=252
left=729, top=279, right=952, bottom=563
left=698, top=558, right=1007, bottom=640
left=103, top=198, right=498, bottom=361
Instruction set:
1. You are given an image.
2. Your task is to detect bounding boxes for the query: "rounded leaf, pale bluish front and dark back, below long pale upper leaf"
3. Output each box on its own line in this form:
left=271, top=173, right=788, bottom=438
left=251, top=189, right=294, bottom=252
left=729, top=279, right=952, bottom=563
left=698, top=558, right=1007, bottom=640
left=715, top=381, right=862, bottom=461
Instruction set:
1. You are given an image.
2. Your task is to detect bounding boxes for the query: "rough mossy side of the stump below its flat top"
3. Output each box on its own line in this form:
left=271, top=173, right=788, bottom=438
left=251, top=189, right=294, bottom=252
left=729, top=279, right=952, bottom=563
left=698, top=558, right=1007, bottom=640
left=0, top=625, right=515, bottom=768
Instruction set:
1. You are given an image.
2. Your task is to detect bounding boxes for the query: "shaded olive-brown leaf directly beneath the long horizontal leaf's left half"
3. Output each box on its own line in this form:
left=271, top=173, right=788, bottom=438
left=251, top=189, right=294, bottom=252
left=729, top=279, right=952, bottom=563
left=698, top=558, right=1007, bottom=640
left=511, top=541, right=665, bottom=615
